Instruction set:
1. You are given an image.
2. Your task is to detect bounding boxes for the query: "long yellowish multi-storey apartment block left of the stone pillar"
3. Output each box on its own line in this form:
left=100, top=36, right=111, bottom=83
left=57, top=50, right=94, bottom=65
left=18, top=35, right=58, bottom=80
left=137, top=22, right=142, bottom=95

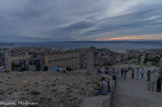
left=45, top=51, right=80, bottom=71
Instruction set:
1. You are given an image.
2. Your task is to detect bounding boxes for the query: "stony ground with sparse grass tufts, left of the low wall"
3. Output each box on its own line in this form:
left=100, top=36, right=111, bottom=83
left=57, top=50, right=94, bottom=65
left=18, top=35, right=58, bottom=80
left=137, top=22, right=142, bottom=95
left=0, top=71, right=100, bottom=107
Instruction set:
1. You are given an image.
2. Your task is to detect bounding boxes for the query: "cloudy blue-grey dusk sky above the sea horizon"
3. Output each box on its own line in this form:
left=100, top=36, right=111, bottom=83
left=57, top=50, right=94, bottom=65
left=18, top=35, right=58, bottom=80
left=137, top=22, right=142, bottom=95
left=0, top=0, right=162, bottom=42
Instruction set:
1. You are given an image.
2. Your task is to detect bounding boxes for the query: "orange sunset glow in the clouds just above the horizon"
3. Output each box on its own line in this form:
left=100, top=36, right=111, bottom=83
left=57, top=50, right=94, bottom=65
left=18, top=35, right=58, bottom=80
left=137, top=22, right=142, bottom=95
left=96, top=35, right=162, bottom=41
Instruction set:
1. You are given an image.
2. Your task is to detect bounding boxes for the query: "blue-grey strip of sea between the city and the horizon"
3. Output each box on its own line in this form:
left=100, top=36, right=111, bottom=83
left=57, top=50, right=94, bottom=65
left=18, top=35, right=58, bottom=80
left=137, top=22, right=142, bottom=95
left=0, top=41, right=162, bottom=53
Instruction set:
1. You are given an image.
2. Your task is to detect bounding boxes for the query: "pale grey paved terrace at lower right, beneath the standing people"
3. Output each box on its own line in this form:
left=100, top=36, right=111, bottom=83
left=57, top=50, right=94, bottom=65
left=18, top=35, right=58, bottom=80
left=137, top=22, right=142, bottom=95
left=112, top=72, right=162, bottom=107
